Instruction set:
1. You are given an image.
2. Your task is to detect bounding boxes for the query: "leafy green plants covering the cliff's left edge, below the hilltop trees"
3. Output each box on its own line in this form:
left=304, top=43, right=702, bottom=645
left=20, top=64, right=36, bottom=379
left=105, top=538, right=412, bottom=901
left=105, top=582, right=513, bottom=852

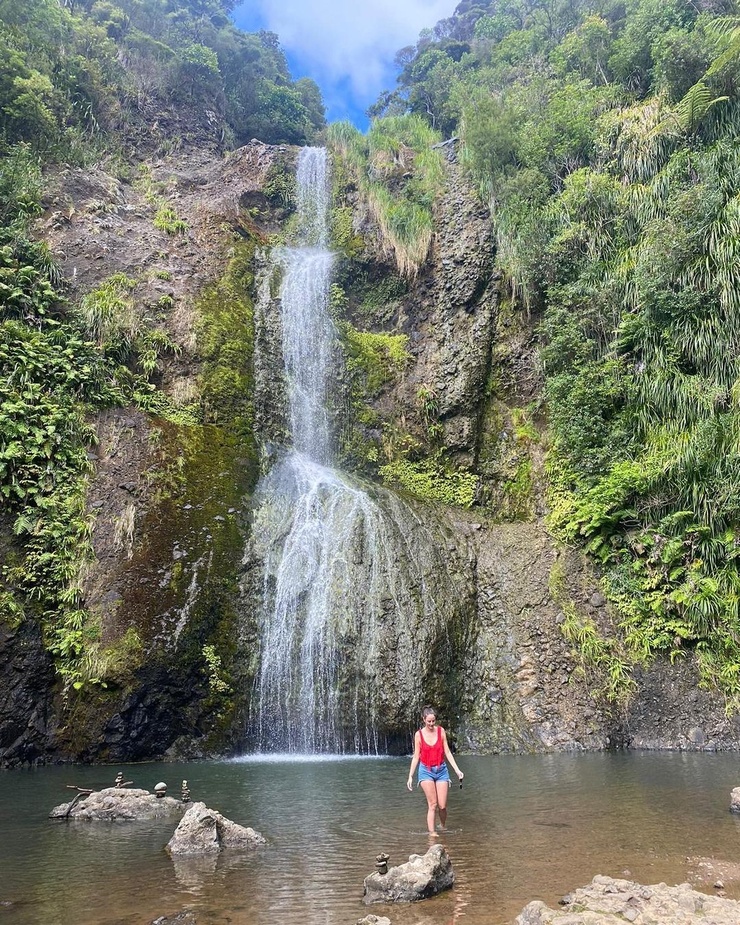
left=0, top=147, right=179, bottom=692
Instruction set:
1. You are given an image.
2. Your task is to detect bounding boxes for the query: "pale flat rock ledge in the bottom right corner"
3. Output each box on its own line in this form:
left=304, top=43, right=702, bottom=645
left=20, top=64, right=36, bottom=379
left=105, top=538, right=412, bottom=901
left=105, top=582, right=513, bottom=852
left=516, top=876, right=740, bottom=925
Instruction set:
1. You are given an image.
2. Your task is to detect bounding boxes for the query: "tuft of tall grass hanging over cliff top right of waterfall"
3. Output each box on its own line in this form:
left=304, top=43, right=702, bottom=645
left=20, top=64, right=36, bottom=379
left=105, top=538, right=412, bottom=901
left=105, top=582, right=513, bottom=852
left=328, top=116, right=444, bottom=276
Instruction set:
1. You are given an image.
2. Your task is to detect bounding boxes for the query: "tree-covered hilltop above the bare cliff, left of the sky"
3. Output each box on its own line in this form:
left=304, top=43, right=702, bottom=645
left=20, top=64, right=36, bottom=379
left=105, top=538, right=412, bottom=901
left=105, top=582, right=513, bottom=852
left=0, top=0, right=324, bottom=159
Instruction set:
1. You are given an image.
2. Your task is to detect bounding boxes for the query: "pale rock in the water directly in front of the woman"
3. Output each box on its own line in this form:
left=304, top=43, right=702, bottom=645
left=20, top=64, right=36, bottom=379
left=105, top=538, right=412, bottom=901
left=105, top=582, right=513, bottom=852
left=363, top=845, right=455, bottom=905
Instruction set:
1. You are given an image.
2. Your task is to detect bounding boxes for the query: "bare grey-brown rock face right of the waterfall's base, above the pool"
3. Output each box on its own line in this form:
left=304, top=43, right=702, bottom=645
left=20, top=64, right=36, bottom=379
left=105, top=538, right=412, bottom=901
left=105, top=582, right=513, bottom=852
left=462, top=517, right=740, bottom=753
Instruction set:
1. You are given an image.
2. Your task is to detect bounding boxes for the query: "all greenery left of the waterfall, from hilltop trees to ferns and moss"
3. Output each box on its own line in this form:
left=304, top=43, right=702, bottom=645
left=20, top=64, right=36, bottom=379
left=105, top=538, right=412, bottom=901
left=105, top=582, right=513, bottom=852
left=0, top=0, right=324, bottom=693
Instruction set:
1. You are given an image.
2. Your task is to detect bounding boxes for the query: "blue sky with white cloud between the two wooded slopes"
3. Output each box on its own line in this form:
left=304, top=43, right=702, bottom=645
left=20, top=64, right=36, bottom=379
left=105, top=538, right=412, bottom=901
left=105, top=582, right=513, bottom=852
left=233, top=0, right=458, bottom=130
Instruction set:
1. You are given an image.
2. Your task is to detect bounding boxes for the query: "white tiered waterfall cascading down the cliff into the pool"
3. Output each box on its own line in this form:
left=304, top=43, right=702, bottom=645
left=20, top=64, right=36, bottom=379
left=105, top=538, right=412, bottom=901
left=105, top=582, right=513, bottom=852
left=249, top=148, right=468, bottom=753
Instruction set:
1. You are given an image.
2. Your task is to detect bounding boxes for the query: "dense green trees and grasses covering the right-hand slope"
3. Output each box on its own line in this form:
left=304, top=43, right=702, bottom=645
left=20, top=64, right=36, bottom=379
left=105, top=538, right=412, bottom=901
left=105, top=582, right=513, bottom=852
left=373, top=0, right=740, bottom=709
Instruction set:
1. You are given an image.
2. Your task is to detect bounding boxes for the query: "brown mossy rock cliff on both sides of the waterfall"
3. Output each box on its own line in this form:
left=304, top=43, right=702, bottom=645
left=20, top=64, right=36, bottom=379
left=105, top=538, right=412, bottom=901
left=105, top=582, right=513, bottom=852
left=0, top=142, right=740, bottom=765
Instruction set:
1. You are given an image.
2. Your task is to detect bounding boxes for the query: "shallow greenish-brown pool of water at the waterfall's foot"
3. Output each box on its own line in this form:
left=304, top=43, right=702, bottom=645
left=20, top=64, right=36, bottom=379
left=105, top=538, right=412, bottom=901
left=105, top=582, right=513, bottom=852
left=0, top=753, right=740, bottom=925
